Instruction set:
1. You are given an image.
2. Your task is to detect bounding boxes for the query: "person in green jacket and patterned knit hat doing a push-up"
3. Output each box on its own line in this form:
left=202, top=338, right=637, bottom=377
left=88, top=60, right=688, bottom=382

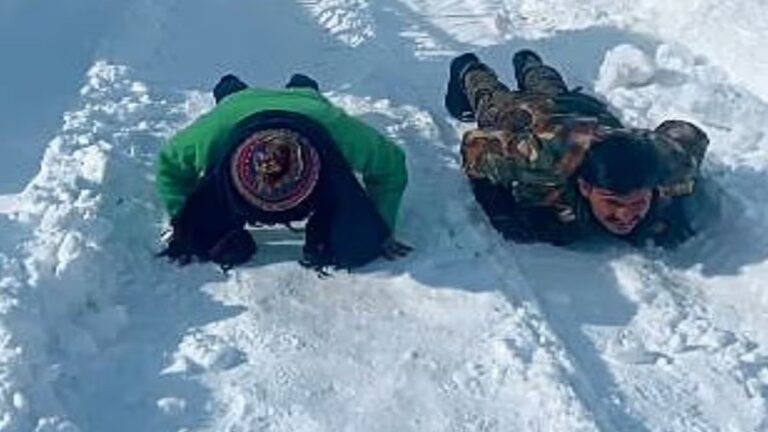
left=155, top=74, right=411, bottom=268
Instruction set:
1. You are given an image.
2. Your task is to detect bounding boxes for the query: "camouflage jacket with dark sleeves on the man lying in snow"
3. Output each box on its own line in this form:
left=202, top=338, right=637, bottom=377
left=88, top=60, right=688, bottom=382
left=461, top=93, right=707, bottom=245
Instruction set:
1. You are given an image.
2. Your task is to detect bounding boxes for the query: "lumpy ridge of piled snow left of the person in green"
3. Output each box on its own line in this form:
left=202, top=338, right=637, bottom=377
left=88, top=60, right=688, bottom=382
left=0, top=62, right=198, bottom=432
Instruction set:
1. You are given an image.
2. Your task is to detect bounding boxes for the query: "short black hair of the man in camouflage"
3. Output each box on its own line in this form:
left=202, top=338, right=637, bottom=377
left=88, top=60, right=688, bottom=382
left=578, top=130, right=661, bottom=194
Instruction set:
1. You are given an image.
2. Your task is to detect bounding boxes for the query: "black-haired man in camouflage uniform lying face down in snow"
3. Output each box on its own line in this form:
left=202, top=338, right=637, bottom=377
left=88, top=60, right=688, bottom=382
left=445, top=50, right=708, bottom=247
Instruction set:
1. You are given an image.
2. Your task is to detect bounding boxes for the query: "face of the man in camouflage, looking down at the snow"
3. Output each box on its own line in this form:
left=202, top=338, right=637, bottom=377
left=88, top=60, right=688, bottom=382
left=579, top=179, right=653, bottom=235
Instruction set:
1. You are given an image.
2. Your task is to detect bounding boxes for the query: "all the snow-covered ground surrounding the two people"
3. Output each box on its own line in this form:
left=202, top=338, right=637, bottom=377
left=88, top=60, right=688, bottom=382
left=0, top=0, right=768, bottom=432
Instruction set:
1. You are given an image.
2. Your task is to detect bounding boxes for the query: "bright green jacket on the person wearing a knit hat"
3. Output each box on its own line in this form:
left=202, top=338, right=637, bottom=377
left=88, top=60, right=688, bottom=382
left=155, top=88, right=408, bottom=229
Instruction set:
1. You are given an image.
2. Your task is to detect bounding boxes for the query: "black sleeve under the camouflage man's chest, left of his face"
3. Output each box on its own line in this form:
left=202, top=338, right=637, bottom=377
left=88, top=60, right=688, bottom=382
left=470, top=179, right=575, bottom=245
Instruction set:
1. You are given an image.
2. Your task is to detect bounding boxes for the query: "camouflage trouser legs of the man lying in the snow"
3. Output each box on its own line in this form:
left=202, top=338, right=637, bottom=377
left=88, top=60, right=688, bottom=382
left=464, top=64, right=568, bottom=130
